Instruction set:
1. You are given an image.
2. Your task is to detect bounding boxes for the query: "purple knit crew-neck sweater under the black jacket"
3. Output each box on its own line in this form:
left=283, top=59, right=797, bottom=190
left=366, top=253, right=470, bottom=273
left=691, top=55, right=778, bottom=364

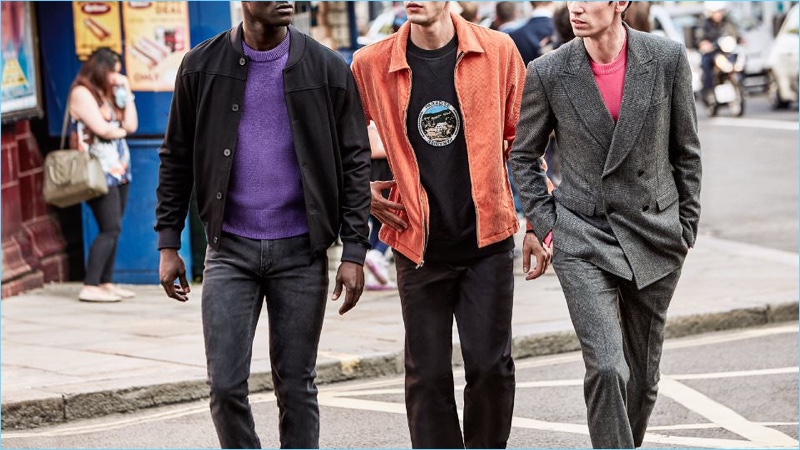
left=222, top=33, right=308, bottom=239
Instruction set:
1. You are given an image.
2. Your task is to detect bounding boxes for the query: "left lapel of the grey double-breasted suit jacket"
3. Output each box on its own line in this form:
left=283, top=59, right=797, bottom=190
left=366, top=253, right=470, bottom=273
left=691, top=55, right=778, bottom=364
left=561, top=38, right=615, bottom=149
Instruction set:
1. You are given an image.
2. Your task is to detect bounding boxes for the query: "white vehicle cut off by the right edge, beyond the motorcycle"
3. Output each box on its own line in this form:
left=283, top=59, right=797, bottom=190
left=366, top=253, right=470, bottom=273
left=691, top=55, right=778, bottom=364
left=766, top=5, right=800, bottom=109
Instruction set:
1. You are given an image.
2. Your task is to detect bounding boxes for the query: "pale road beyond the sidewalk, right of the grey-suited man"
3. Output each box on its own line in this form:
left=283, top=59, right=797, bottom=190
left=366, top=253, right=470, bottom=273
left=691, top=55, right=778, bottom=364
left=697, top=91, right=798, bottom=253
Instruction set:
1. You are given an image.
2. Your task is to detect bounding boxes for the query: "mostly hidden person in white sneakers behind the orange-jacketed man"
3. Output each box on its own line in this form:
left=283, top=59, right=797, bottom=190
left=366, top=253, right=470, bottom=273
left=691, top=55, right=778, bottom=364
left=364, top=121, right=399, bottom=291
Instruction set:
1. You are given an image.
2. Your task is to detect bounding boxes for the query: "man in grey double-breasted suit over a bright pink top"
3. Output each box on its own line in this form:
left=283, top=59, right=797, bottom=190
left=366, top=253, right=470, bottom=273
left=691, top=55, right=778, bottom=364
left=511, top=1, right=702, bottom=448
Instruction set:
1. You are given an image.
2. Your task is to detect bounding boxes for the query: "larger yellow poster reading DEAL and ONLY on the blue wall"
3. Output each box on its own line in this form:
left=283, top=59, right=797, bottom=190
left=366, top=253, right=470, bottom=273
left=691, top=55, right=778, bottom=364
left=122, top=2, right=190, bottom=92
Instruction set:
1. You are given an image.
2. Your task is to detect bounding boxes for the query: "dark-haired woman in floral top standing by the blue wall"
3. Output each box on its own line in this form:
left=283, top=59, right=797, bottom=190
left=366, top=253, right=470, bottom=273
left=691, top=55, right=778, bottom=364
left=68, top=48, right=139, bottom=302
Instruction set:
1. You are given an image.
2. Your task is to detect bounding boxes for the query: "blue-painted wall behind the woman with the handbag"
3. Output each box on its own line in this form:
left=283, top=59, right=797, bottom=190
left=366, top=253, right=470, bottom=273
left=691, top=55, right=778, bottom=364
left=34, top=2, right=231, bottom=284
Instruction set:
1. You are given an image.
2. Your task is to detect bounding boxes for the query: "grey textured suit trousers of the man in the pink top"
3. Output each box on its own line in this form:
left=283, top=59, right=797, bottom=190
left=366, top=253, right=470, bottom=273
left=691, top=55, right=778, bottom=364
left=553, top=250, right=680, bottom=448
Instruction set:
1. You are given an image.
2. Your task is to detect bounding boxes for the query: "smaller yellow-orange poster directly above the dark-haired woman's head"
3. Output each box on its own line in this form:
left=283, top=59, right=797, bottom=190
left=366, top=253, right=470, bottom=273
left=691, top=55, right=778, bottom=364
left=72, top=2, right=122, bottom=61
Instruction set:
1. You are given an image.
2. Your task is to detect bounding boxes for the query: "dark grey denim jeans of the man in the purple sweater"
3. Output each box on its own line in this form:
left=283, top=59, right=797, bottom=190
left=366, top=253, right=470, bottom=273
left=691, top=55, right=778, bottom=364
left=202, top=233, right=328, bottom=448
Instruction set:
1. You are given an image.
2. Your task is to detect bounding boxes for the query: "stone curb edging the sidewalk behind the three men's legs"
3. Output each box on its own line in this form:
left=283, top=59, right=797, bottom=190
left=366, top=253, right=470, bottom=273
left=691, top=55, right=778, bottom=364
left=2, top=302, right=798, bottom=430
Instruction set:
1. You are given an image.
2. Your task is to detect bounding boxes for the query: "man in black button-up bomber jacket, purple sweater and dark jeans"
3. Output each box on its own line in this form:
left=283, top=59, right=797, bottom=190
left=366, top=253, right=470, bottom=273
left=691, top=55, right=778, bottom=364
left=155, top=2, right=370, bottom=448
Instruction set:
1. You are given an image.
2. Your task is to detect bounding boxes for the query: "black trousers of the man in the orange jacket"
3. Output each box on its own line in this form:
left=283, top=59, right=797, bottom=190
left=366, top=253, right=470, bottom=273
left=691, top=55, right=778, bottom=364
left=394, top=251, right=515, bottom=448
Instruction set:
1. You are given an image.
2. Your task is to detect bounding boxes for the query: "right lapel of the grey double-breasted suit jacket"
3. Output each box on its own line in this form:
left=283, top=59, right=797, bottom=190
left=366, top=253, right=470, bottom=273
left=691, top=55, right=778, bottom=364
left=603, top=25, right=657, bottom=177
